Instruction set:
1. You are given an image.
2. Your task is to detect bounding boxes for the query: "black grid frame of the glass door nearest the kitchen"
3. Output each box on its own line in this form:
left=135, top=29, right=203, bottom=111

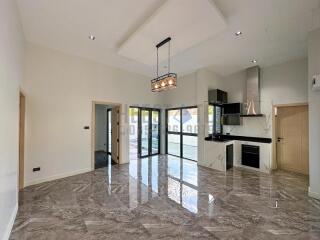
left=165, top=106, right=198, bottom=162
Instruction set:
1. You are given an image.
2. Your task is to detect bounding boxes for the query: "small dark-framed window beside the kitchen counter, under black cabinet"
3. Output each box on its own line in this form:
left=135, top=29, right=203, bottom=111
left=208, top=104, right=223, bottom=134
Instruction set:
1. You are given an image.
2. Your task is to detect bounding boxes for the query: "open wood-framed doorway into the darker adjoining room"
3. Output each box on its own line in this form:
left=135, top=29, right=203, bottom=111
left=92, top=102, right=120, bottom=169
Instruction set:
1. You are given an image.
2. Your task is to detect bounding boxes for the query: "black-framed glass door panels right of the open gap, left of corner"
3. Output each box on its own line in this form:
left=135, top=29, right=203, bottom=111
left=138, top=108, right=160, bottom=157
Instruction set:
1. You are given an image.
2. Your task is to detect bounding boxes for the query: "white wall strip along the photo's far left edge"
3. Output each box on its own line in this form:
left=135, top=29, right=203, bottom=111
left=0, top=0, right=24, bottom=239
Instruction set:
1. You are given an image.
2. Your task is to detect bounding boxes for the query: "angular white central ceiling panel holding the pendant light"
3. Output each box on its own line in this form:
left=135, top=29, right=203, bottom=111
left=119, top=0, right=227, bottom=66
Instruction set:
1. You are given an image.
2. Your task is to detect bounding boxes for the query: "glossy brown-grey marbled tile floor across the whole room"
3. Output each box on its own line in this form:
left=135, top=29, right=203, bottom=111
left=10, top=156, right=320, bottom=240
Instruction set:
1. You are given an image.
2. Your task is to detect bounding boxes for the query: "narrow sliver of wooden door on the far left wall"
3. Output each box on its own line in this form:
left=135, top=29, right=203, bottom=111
left=19, top=93, right=26, bottom=190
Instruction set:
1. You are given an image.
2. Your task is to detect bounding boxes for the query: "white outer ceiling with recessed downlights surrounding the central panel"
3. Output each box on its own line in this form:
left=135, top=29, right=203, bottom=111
left=16, top=0, right=320, bottom=76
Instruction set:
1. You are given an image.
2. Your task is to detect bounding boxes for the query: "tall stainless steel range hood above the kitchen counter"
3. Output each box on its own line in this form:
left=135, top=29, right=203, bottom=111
left=241, top=66, right=263, bottom=117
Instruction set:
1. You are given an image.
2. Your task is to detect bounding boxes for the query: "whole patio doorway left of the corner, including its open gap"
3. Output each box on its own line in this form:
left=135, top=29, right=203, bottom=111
left=129, top=107, right=161, bottom=160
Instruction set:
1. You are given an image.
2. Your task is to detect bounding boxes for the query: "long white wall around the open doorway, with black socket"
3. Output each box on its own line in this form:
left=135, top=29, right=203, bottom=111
left=24, top=44, right=160, bottom=184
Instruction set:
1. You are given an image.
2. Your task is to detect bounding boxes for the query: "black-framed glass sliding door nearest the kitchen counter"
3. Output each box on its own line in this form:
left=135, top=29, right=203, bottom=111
left=166, top=107, right=198, bottom=161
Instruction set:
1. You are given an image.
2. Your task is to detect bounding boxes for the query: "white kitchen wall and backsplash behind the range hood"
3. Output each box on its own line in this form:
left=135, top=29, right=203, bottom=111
left=224, top=59, right=308, bottom=138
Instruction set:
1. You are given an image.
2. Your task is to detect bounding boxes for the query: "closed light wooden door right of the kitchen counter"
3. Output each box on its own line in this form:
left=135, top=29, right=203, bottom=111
left=277, top=106, right=309, bottom=174
